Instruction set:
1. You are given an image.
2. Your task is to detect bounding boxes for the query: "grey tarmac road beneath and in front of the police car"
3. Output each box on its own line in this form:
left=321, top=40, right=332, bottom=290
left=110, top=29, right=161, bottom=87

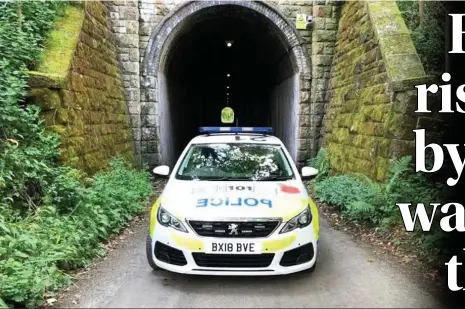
left=54, top=206, right=441, bottom=308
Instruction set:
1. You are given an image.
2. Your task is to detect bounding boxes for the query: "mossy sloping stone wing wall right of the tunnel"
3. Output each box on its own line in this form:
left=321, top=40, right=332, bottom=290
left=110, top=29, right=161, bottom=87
left=322, top=1, right=437, bottom=180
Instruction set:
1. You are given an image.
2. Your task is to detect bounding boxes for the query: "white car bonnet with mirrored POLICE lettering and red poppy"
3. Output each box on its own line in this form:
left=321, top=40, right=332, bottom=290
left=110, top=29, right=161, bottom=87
left=160, top=180, right=308, bottom=221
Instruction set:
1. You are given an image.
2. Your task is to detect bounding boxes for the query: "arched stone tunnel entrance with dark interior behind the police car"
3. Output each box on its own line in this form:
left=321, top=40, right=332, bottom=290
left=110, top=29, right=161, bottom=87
left=140, top=1, right=310, bottom=167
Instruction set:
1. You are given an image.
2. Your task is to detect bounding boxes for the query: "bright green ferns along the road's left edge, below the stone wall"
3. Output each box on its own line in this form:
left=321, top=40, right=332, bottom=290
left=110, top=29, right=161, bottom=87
left=0, top=159, right=152, bottom=307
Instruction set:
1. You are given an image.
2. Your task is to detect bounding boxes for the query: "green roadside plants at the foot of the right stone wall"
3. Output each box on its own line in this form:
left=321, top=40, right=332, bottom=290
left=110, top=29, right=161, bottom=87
left=308, top=149, right=446, bottom=262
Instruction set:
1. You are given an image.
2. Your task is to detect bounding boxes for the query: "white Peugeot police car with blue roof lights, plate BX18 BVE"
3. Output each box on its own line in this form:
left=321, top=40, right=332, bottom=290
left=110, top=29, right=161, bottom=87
left=146, top=127, right=319, bottom=276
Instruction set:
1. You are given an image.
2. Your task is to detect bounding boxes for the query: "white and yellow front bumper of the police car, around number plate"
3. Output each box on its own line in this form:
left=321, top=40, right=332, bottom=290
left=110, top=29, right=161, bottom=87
left=151, top=222, right=318, bottom=276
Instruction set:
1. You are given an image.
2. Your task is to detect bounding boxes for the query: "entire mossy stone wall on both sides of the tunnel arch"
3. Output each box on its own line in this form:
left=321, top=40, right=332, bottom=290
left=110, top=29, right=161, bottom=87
left=24, top=0, right=436, bottom=179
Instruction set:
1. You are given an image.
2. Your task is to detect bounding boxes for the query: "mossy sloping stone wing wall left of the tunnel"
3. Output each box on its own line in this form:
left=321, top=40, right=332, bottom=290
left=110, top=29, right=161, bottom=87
left=28, top=1, right=134, bottom=175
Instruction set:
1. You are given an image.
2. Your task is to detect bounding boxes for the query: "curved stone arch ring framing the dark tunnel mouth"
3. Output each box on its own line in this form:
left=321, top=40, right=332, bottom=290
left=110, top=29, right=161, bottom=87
left=140, top=0, right=315, bottom=161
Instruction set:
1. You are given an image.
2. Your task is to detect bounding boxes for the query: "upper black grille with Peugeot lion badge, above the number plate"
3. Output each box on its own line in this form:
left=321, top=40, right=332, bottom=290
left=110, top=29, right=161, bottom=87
left=189, top=220, right=280, bottom=238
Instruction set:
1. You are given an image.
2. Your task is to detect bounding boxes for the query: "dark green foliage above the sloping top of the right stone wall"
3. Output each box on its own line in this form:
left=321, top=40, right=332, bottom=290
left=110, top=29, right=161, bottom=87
left=397, top=0, right=447, bottom=75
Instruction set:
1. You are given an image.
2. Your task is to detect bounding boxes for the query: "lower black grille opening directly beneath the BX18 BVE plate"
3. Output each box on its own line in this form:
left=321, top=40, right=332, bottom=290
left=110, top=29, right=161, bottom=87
left=192, top=252, right=274, bottom=268
